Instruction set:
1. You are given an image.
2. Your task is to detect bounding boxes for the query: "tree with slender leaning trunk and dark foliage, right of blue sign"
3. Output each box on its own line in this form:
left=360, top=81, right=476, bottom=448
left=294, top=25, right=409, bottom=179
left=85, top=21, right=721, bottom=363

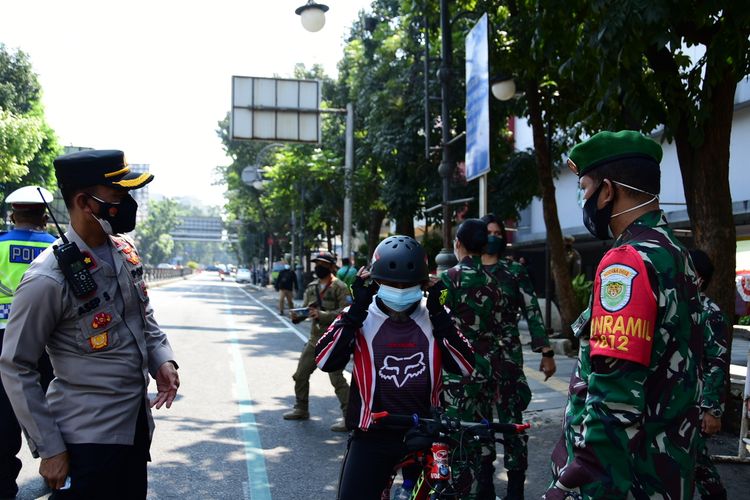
left=464, top=1, right=580, bottom=334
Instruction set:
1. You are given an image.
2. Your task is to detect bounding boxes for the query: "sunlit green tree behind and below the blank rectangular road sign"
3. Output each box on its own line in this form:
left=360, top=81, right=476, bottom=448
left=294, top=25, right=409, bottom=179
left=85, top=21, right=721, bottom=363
left=217, top=65, right=344, bottom=268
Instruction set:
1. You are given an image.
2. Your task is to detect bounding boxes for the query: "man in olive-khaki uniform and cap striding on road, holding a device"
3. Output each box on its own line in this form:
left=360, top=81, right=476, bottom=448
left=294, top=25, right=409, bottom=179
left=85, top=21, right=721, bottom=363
left=283, top=252, right=352, bottom=432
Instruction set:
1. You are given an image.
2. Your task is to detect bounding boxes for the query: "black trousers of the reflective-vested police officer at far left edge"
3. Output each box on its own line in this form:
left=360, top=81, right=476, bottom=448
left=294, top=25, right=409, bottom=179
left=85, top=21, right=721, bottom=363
left=0, top=329, right=53, bottom=498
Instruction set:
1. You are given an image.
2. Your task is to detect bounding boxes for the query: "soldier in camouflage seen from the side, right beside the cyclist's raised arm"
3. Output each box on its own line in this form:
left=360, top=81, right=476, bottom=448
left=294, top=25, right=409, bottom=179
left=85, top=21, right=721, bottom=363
left=441, top=219, right=505, bottom=499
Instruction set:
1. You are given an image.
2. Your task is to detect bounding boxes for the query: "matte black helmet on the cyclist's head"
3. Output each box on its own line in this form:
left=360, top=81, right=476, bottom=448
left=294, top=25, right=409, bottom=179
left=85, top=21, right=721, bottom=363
left=370, top=235, right=428, bottom=283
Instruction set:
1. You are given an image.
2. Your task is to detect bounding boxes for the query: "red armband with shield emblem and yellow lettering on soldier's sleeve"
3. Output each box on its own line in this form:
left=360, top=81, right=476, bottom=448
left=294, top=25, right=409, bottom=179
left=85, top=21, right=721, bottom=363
left=591, top=245, right=656, bottom=366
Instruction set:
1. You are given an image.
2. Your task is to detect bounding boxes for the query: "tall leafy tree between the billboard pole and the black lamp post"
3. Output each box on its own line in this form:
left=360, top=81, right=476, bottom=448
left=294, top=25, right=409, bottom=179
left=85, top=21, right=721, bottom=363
left=339, top=0, right=431, bottom=238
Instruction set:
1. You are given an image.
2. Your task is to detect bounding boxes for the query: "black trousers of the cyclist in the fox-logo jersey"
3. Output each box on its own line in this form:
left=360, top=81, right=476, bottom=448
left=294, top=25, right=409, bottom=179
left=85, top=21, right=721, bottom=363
left=338, top=431, right=409, bottom=500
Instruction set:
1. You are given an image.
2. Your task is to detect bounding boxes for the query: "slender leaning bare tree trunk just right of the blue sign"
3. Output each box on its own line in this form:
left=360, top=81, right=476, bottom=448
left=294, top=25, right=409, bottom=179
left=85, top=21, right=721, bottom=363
left=526, top=82, right=578, bottom=337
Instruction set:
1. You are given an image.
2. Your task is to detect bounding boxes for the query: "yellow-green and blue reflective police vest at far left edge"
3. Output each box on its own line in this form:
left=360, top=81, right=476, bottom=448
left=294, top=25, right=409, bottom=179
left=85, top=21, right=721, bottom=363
left=0, top=229, right=55, bottom=330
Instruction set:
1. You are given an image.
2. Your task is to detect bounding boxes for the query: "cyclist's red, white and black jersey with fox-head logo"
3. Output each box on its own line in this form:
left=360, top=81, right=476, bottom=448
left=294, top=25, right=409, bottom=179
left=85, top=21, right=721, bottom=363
left=315, top=297, right=474, bottom=430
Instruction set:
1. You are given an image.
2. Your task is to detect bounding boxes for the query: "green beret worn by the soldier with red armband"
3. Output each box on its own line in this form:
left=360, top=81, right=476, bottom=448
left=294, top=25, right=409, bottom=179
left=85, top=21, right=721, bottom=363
left=568, top=130, right=662, bottom=177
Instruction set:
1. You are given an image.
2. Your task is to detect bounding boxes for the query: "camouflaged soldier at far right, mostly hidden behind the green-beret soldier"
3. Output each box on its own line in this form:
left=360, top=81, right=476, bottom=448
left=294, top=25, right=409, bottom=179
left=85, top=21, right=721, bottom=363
left=690, top=250, right=729, bottom=500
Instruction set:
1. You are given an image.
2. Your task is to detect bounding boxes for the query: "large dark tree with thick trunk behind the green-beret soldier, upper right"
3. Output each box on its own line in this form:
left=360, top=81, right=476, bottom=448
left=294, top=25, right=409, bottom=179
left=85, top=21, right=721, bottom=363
left=562, top=0, right=750, bottom=324
